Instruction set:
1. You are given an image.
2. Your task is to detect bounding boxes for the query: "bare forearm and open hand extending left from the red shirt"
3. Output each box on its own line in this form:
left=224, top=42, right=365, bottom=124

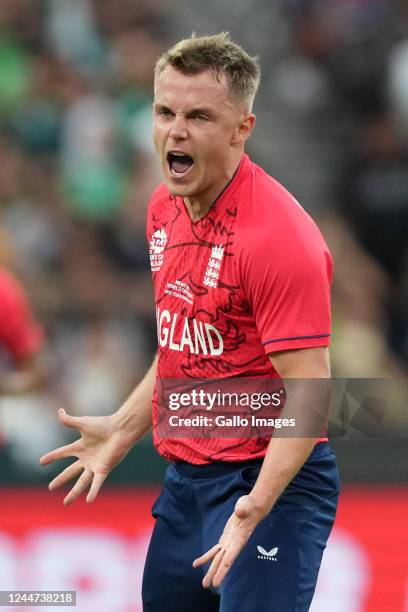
left=40, top=356, right=157, bottom=505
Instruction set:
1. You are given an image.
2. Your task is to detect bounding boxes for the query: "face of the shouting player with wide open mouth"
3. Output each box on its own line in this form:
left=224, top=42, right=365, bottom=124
left=154, top=66, right=254, bottom=204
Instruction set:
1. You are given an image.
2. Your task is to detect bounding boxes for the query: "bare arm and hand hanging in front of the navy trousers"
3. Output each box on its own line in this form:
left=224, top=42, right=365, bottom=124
left=193, top=347, right=330, bottom=588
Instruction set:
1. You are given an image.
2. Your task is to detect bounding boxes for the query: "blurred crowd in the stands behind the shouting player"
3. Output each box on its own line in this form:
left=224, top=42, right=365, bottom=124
left=0, top=0, right=408, bottom=483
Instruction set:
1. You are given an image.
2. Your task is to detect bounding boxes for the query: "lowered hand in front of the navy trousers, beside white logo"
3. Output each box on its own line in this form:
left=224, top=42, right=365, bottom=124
left=193, top=495, right=265, bottom=588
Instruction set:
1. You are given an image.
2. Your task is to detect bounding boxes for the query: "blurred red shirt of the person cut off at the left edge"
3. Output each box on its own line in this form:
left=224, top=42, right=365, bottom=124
left=0, top=271, right=44, bottom=362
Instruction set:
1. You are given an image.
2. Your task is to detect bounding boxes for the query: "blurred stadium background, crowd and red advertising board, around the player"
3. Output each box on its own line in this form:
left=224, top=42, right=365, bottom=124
left=0, top=0, right=408, bottom=612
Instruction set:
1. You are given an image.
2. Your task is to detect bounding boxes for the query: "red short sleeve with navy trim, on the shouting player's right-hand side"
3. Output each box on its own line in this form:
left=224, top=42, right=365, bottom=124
left=237, top=213, right=333, bottom=354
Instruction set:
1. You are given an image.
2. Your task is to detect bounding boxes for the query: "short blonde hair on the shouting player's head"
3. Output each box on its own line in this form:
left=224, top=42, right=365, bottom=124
left=154, top=32, right=261, bottom=109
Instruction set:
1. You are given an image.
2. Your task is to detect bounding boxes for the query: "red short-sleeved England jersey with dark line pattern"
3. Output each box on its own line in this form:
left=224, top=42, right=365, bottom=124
left=147, top=155, right=333, bottom=464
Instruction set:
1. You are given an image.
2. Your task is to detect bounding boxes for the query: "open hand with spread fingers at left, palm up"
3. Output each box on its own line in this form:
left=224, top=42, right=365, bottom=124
left=40, top=408, right=130, bottom=505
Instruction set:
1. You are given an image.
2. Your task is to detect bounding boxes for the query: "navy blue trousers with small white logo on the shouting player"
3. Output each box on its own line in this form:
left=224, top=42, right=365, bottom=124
left=142, top=442, right=339, bottom=612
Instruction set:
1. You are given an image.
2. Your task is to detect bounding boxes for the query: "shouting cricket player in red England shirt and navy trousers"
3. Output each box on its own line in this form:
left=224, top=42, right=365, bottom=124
left=40, top=33, right=339, bottom=612
